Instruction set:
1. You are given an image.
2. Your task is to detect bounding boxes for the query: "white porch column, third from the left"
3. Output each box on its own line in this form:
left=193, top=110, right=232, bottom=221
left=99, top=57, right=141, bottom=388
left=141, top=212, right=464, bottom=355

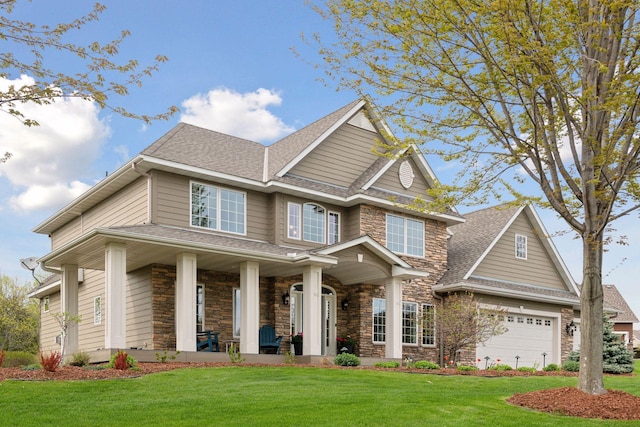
left=175, top=253, right=198, bottom=351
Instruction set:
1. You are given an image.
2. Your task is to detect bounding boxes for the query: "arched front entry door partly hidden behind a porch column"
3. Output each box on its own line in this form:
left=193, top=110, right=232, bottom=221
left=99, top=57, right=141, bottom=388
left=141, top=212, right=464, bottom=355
left=290, top=284, right=337, bottom=356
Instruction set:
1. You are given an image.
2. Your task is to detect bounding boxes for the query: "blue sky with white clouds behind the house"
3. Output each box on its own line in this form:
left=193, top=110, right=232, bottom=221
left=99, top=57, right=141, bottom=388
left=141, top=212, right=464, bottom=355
left=0, top=0, right=640, bottom=324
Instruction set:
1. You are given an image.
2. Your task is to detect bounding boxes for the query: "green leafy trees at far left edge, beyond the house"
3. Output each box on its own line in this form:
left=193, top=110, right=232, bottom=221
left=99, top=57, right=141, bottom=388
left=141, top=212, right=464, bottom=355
left=0, top=276, right=40, bottom=354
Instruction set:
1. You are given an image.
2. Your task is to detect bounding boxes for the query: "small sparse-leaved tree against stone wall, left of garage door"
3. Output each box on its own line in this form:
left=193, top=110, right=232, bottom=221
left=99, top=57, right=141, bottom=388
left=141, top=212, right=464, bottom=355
left=436, top=292, right=507, bottom=361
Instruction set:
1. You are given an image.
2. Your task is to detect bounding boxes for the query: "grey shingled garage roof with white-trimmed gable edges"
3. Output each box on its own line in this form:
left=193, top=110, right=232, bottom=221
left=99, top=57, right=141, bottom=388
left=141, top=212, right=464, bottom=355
left=434, top=205, right=579, bottom=304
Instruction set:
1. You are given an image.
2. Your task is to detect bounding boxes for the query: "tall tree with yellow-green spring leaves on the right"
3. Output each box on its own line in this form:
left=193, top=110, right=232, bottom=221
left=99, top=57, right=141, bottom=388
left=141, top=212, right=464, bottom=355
left=316, top=0, right=640, bottom=394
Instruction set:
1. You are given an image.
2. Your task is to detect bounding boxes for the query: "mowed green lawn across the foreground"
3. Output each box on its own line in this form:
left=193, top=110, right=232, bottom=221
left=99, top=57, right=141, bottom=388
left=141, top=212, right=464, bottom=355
left=0, top=366, right=640, bottom=427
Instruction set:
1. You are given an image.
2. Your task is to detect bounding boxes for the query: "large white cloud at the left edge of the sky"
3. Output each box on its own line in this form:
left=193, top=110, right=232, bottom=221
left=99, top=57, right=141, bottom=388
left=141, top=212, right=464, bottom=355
left=0, top=76, right=110, bottom=211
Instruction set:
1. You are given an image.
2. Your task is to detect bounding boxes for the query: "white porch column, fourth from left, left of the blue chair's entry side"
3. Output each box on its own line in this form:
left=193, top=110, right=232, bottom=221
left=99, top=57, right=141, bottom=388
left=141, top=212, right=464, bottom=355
left=240, top=261, right=260, bottom=354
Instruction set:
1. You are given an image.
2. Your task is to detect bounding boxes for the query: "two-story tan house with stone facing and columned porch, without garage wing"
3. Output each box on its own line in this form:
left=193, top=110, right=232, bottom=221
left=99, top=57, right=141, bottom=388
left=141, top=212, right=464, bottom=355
left=28, top=99, right=463, bottom=360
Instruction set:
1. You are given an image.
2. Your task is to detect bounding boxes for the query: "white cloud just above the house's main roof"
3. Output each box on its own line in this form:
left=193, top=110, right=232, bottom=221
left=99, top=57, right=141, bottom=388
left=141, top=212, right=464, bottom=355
left=180, top=88, right=295, bottom=142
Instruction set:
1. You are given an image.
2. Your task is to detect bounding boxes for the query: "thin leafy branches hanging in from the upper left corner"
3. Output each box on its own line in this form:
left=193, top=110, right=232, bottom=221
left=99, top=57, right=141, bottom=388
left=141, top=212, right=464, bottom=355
left=0, top=0, right=178, bottom=137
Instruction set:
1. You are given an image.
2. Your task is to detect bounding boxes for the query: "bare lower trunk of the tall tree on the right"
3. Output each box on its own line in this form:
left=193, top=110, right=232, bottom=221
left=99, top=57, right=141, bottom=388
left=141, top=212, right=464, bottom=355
left=578, top=234, right=607, bottom=394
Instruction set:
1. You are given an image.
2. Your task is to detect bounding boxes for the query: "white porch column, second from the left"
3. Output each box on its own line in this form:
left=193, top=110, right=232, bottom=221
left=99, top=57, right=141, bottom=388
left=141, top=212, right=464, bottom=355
left=104, top=243, right=127, bottom=349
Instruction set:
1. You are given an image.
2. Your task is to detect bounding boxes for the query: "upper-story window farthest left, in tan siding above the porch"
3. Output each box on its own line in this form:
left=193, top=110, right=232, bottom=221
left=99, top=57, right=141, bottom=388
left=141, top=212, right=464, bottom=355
left=191, top=182, right=246, bottom=234
